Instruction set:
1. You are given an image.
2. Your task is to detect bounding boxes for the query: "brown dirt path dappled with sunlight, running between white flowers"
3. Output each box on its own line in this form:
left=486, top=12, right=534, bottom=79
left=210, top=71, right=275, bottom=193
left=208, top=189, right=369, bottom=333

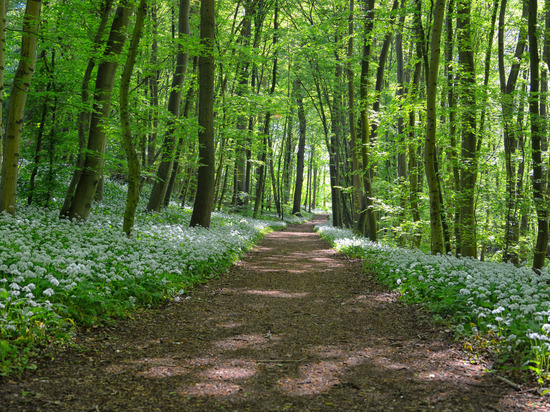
left=0, top=216, right=550, bottom=411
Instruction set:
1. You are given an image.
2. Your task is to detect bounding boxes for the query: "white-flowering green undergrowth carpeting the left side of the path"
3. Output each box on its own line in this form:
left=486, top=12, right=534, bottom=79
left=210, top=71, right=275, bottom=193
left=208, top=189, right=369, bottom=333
left=0, top=182, right=292, bottom=376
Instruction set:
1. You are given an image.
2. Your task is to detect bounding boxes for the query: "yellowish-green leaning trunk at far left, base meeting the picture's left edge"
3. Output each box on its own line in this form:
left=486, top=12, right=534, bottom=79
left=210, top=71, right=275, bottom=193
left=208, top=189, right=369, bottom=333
left=0, top=0, right=42, bottom=215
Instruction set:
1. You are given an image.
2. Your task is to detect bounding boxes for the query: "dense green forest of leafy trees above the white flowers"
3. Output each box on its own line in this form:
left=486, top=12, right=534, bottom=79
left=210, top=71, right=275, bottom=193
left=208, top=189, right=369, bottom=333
left=0, top=0, right=550, bottom=270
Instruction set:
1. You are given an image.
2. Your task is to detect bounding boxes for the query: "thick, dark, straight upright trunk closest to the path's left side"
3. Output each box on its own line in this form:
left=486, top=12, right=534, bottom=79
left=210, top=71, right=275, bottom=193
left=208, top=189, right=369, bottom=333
left=190, top=0, right=216, bottom=228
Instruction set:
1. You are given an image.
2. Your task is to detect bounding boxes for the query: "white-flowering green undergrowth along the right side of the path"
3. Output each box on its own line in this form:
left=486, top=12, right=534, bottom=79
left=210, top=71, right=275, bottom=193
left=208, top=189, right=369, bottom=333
left=317, top=220, right=550, bottom=387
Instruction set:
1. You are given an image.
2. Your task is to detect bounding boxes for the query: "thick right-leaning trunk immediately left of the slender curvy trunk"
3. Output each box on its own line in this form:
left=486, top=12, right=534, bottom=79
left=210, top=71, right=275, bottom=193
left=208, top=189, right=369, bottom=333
left=68, top=0, right=133, bottom=220
